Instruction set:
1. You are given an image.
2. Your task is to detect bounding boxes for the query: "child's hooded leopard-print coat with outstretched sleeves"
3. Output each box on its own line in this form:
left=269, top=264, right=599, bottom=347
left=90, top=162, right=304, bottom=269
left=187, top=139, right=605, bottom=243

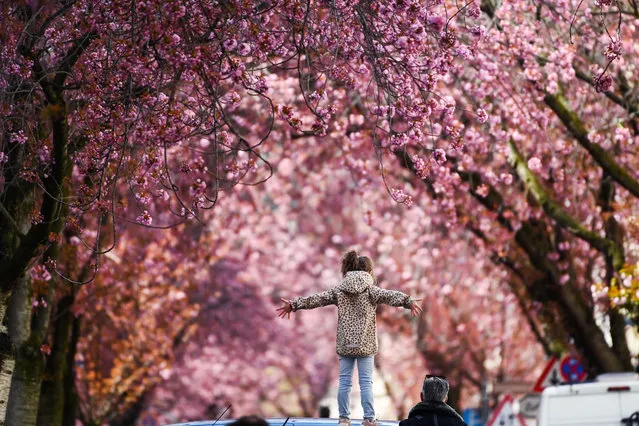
left=291, top=271, right=413, bottom=357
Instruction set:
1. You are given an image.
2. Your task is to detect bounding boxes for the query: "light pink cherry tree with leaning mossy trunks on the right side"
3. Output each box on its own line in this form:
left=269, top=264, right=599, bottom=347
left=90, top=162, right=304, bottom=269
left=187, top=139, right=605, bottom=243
left=406, top=2, right=637, bottom=372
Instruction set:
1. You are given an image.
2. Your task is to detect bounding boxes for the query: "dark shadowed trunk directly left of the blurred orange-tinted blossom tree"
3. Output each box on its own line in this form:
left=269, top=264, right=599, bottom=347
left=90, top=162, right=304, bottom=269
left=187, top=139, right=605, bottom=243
left=38, top=290, right=75, bottom=426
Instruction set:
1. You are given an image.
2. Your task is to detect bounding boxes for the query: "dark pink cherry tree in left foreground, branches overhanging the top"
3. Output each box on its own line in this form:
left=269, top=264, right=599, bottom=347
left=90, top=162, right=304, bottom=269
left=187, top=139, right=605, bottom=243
left=0, top=0, right=470, bottom=424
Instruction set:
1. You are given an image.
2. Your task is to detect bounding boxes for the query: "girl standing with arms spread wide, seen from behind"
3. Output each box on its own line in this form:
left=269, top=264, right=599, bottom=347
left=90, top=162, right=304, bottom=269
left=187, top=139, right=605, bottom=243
left=277, top=250, right=422, bottom=426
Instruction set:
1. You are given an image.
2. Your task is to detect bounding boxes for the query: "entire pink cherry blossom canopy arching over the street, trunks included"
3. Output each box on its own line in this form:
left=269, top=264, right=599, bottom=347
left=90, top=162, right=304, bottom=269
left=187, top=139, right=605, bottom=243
left=0, top=0, right=639, bottom=425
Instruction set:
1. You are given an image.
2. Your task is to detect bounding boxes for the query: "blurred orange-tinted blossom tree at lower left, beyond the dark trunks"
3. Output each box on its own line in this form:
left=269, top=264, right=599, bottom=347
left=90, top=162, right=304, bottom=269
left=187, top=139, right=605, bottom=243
left=71, top=231, right=200, bottom=425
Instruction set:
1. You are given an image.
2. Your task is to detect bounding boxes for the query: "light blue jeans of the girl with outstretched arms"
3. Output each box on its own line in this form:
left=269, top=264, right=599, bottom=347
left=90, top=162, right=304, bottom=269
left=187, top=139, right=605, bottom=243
left=337, top=356, right=375, bottom=420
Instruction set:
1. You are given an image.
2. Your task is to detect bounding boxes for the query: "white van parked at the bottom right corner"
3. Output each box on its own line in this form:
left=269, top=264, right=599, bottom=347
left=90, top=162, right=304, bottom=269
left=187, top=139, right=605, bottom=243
left=537, top=373, right=639, bottom=426
